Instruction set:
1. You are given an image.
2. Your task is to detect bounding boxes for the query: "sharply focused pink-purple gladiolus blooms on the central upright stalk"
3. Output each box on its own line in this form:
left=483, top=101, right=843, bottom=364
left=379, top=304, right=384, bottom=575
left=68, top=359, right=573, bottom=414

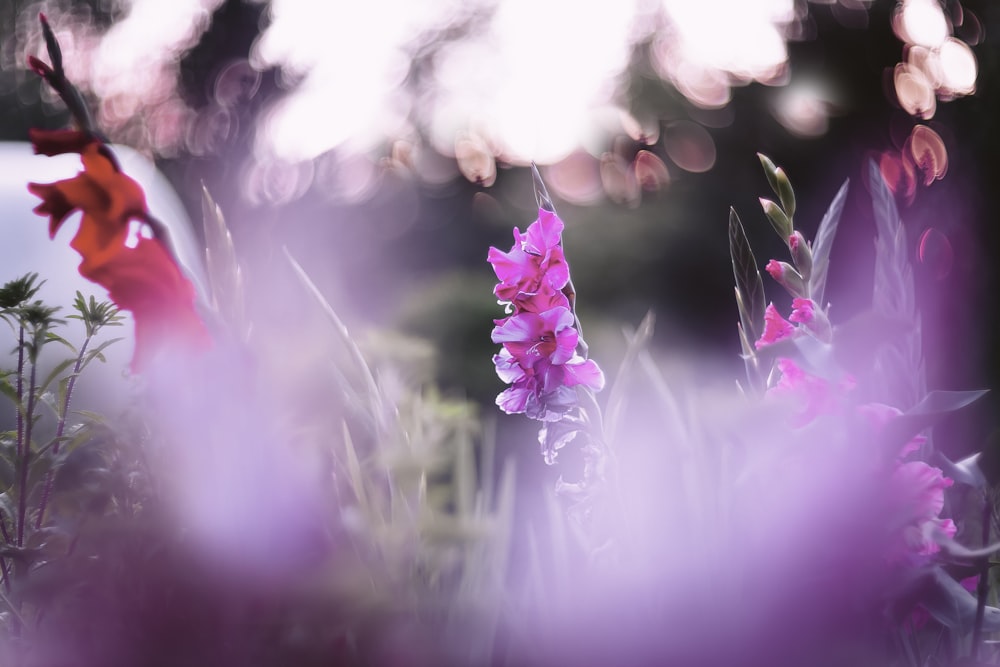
left=488, top=209, right=604, bottom=422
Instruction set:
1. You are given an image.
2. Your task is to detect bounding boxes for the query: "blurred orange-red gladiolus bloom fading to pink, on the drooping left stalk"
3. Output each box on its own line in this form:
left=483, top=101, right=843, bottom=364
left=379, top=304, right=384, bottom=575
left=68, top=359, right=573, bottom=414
left=28, top=130, right=210, bottom=371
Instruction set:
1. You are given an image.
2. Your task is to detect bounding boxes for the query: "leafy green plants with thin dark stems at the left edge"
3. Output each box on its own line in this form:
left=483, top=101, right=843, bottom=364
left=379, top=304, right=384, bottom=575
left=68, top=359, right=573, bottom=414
left=0, top=274, right=122, bottom=648
